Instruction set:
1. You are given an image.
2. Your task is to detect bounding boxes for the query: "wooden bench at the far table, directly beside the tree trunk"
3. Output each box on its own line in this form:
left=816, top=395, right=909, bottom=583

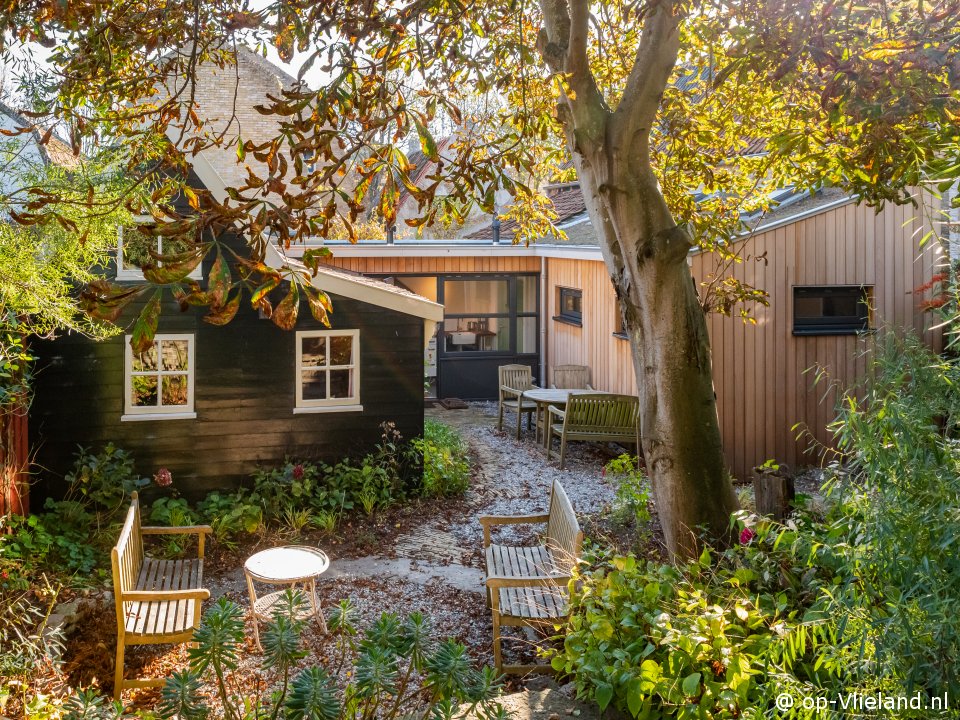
left=546, top=394, right=640, bottom=469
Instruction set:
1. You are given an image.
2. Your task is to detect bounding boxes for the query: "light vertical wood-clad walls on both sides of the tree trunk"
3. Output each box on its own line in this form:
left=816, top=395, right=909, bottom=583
left=545, top=202, right=942, bottom=479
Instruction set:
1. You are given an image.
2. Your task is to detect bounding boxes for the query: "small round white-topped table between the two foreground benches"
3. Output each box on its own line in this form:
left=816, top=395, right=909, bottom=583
left=243, top=545, right=330, bottom=650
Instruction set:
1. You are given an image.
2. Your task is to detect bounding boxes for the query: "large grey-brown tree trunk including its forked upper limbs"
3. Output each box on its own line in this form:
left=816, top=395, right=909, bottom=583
left=537, top=0, right=737, bottom=556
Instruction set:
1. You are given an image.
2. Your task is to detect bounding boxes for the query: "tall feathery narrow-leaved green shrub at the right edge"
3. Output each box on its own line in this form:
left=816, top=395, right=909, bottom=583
left=820, top=334, right=960, bottom=698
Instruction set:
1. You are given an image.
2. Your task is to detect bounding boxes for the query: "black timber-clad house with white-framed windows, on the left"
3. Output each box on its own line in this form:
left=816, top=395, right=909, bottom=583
left=30, top=66, right=443, bottom=497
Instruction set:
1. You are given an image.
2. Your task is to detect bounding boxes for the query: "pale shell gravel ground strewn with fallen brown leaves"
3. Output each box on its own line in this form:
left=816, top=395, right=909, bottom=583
left=62, top=403, right=622, bottom=708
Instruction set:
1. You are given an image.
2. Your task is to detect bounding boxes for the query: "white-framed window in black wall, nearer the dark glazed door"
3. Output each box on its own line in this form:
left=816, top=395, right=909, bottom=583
left=294, top=330, right=363, bottom=412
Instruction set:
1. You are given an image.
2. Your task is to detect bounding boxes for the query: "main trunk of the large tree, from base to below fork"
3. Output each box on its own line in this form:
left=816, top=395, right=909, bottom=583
left=579, top=157, right=738, bottom=557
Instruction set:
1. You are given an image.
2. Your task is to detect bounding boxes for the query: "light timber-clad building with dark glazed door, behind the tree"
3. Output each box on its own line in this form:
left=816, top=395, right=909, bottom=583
left=314, top=184, right=945, bottom=478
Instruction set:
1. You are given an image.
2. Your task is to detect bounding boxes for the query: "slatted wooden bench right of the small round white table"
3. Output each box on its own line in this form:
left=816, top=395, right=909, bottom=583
left=480, top=482, right=583, bottom=674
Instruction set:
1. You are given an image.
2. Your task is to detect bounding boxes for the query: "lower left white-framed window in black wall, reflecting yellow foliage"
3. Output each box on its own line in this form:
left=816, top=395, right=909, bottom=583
left=121, top=335, right=196, bottom=420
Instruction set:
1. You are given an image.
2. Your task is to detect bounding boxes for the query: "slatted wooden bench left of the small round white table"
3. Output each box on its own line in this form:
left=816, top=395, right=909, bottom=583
left=111, top=493, right=211, bottom=700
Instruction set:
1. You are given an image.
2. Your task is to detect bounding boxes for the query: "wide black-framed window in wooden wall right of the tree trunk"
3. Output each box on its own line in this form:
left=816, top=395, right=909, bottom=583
left=793, top=285, right=870, bottom=335
